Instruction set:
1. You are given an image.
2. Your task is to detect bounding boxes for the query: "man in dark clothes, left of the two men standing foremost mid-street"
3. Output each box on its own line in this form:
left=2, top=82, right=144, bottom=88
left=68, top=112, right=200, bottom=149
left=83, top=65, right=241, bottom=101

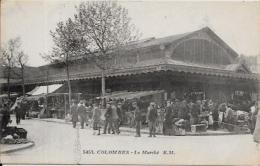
left=132, top=102, right=142, bottom=137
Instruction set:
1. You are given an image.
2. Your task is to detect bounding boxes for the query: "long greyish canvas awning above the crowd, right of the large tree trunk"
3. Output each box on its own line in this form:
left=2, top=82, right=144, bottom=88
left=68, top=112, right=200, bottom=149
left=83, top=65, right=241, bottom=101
left=98, top=90, right=164, bottom=99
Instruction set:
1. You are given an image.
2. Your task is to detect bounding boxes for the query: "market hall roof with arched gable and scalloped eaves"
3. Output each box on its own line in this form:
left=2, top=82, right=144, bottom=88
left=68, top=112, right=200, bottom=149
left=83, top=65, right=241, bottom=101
left=22, top=27, right=257, bottom=84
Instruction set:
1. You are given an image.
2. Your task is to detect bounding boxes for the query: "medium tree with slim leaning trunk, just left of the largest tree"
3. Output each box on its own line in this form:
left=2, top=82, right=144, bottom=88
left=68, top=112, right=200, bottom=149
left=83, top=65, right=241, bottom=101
left=43, top=18, right=84, bottom=110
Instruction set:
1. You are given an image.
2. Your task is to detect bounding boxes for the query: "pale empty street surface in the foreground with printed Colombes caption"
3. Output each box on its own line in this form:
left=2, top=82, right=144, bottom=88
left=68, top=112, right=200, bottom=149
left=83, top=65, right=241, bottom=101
left=0, top=116, right=260, bottom=165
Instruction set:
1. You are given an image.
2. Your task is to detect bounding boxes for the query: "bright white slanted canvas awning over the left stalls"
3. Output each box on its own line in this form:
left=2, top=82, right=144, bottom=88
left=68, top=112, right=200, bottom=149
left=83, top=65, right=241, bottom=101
left=27, top=84, right=63, bottom=96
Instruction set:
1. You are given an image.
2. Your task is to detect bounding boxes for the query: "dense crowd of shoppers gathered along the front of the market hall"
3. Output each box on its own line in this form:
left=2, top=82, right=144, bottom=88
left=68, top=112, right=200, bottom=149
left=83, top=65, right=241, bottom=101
left=66, top=99, right=257, bottom=137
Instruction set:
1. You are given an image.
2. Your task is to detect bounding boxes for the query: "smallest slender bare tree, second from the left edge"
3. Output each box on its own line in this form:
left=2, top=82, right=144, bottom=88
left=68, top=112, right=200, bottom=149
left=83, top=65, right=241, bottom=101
left=16, top=51, right=28, bottom=96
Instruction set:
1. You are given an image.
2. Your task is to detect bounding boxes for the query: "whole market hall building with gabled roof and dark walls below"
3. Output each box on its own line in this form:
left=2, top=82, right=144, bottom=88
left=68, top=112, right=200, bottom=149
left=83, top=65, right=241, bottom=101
left=20, top=27, right=258, bottom=105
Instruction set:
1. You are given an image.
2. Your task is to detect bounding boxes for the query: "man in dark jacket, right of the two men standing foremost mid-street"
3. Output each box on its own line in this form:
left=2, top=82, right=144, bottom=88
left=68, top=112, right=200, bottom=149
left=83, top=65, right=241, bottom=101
left=147, top=102, right=158, bottom=137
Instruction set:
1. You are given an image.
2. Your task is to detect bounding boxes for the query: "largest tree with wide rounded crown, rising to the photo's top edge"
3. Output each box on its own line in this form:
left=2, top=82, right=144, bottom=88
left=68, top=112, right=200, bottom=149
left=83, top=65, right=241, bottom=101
left=75, top=1, right=139, bottom=96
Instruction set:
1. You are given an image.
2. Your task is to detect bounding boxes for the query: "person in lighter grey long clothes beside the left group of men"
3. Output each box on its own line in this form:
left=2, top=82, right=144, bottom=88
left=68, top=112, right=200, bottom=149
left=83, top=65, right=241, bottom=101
left=92, top=103, right=101, bottom=135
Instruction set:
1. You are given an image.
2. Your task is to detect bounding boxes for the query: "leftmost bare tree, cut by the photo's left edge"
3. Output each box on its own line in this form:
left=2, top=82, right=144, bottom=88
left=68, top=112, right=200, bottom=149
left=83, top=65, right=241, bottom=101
left=1, top=37, right=21, bottom=99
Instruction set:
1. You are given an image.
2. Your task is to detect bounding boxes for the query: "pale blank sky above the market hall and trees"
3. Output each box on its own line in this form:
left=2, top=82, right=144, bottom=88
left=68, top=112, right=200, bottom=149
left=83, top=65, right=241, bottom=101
left=1, top=0, right=260, bottom=66
